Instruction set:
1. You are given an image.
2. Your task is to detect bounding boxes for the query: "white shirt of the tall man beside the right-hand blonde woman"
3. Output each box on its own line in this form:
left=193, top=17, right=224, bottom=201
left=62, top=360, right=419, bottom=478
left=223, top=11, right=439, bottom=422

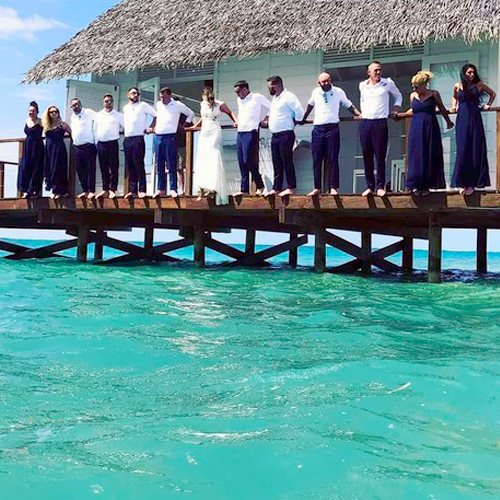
left=359, top=78, right=403, bottom=120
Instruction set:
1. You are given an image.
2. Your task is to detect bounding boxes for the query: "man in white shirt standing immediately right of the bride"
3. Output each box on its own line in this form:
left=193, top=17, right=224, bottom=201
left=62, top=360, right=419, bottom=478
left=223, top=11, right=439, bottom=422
left=234, top=80, right=271, bottom=196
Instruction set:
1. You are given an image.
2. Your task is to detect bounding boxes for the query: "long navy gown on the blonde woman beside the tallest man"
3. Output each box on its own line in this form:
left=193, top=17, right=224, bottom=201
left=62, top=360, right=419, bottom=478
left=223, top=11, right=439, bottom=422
left=406, top=96, right=446, bottom=191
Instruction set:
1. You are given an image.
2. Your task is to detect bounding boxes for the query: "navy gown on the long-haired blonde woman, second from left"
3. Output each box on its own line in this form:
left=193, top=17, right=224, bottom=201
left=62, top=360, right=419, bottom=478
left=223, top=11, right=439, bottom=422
left=45, top=127, right=68, bottom=195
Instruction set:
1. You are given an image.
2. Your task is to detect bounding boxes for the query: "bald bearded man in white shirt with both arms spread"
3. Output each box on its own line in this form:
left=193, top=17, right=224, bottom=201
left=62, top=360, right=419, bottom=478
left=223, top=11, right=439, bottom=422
left=302, top=73, right=360, bottom=196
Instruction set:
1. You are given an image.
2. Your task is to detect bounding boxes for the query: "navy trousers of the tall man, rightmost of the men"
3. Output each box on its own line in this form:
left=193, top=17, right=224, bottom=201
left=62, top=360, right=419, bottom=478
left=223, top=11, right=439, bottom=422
left=359, top=118, right=389, bottom=191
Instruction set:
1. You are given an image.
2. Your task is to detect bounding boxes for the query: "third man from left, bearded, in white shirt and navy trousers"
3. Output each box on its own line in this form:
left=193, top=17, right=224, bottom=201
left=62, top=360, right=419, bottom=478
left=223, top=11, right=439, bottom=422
left=123, top=87, right=156, bottom=198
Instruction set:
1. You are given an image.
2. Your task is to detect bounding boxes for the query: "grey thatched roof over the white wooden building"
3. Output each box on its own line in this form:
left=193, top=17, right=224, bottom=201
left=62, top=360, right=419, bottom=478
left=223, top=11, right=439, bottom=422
left=25, top=0, right=500, bottom=82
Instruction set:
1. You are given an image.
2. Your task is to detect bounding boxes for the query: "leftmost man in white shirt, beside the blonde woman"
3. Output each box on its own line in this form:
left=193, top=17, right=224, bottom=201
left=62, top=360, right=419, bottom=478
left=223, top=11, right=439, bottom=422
left=70, top=97, right=96, bottom=199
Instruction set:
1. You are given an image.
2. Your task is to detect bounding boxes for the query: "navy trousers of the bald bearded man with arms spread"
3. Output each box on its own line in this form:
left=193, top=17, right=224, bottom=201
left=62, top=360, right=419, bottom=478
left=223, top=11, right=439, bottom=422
left=311, top=123, right=340, bottom=190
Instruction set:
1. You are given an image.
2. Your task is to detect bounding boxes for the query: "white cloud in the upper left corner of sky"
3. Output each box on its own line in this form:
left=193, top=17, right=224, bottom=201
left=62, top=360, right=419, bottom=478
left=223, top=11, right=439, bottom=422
left=0, top=6, right=66, bottom=41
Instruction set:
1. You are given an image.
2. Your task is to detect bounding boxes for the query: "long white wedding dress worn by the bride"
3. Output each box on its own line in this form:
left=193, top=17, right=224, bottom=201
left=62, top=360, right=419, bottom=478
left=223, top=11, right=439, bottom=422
left=194, top=100, right=229, bottom=205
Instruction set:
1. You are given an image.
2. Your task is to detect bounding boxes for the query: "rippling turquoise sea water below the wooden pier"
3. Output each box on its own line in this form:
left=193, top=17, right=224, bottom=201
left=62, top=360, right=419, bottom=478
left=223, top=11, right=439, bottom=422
left=0, top=244, right=500, bottom=500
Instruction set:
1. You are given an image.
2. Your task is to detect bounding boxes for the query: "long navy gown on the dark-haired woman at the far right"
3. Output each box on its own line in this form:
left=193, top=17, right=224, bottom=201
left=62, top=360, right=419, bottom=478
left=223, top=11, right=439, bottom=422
left=451, top=87, right=490, bottom=188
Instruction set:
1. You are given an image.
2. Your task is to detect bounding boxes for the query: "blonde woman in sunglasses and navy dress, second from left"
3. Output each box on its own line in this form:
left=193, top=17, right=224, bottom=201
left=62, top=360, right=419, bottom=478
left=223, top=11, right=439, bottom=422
left=42, top=106, right=71, bottom=199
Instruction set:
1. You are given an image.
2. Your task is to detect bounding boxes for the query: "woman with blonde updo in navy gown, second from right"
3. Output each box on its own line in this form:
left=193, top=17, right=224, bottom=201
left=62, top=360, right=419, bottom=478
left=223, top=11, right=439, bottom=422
left=406, top=71, right=453, bottom=195
